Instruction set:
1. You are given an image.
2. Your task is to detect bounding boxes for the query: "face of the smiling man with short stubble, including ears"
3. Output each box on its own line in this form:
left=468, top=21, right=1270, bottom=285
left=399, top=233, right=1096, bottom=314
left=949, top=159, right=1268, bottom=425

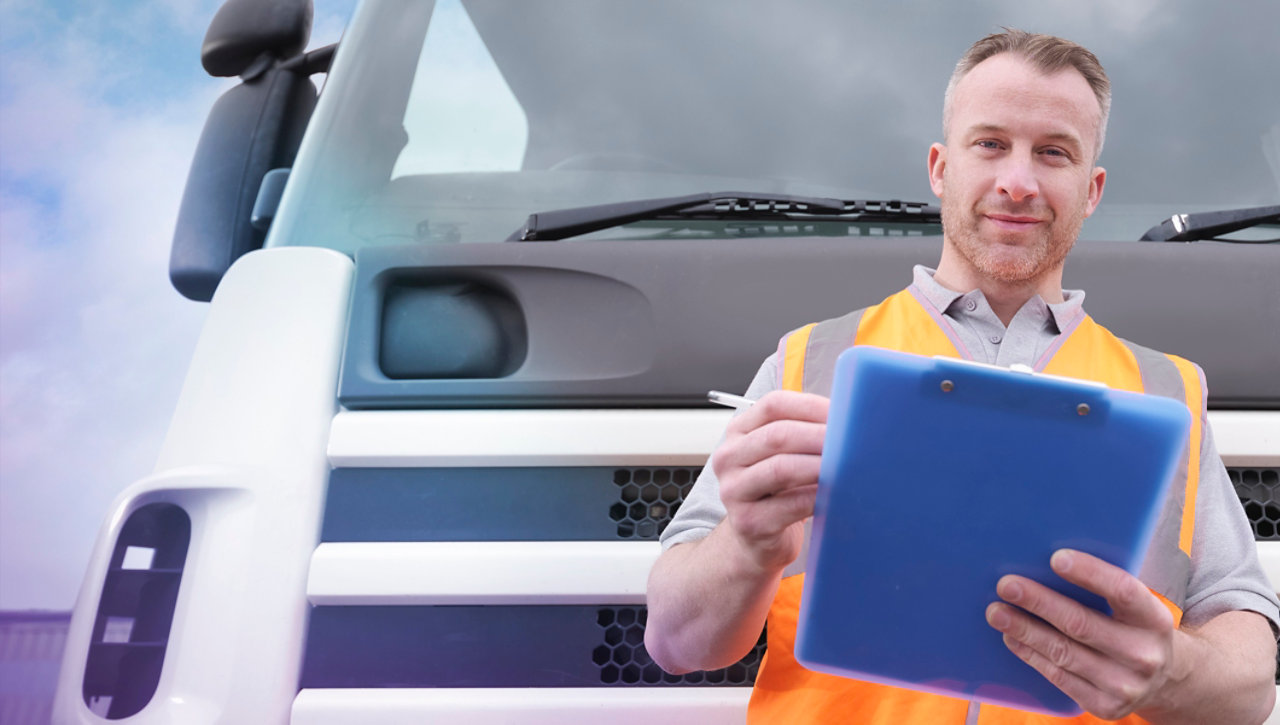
left=929, top=54, right=1106, bottom=284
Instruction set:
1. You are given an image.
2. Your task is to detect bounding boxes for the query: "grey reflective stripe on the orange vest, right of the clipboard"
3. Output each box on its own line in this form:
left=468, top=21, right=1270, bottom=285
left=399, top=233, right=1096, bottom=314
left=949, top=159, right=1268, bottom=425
left=1120, top=339, right=1194, bottom=608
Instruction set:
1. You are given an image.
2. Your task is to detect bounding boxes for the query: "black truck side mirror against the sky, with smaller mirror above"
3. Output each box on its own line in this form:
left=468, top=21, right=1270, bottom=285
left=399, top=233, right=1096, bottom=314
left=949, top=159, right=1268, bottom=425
left=169, top=0, right=325, bottom=301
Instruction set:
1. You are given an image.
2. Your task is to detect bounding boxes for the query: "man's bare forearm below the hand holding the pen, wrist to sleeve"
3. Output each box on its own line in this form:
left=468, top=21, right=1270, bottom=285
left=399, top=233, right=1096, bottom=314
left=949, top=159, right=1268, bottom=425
left=645, top=523, right=782, bottom=674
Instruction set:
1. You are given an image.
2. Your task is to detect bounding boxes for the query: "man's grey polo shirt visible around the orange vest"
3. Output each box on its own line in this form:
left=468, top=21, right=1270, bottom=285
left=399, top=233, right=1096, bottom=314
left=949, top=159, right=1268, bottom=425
left=660, top=266, right=1280, bottom=628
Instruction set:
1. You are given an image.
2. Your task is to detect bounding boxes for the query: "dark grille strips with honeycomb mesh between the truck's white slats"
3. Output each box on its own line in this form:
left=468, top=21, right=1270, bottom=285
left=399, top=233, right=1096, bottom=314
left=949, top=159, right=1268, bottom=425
left=302, top=466, right=1280, bottom=688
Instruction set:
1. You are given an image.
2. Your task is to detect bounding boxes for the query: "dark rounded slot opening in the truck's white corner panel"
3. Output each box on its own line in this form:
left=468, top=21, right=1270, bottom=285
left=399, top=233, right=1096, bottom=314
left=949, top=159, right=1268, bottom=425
left=83, top=503, right=191, bottom=720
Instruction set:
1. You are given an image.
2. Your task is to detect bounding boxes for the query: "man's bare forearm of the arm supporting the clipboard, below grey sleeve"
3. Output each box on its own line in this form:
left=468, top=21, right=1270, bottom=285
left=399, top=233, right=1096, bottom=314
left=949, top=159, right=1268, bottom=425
left=1138, top=611, right=1276, bottom=725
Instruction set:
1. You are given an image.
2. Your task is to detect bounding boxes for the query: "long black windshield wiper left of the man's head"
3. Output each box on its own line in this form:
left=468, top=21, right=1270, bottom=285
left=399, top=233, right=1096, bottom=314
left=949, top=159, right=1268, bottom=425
left=507, top=191, right=942, bottom=242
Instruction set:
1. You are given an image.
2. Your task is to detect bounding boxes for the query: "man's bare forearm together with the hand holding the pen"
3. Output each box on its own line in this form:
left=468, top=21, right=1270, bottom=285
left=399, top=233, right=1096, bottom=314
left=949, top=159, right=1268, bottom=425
left=645, top=391, right=828, bottom=672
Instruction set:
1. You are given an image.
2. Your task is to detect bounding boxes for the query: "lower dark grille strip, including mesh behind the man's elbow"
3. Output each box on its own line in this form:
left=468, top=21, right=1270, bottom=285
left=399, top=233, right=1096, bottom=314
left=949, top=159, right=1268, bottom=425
left=301, top=605, right=764, bottom=688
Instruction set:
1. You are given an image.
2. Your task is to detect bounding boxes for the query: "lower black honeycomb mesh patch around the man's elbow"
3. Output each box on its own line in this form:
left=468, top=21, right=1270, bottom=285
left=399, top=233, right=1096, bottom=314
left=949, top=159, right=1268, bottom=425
left=591, top=607, right=764, bottom=687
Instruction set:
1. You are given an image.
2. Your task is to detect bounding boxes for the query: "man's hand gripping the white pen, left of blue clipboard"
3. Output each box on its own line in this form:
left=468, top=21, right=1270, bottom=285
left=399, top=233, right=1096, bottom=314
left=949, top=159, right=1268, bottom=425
left=712, top=391, right=829, bottom=571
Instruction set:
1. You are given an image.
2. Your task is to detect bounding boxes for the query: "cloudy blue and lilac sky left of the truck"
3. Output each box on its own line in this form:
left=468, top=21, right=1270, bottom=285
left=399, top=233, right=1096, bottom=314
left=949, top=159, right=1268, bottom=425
left=0, top=0, right=355, bottom=611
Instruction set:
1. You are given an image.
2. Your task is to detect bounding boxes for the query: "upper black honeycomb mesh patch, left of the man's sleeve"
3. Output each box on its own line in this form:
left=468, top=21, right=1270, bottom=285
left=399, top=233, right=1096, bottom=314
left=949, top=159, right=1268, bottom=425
left=609, top=468, right=703, bottom=539
